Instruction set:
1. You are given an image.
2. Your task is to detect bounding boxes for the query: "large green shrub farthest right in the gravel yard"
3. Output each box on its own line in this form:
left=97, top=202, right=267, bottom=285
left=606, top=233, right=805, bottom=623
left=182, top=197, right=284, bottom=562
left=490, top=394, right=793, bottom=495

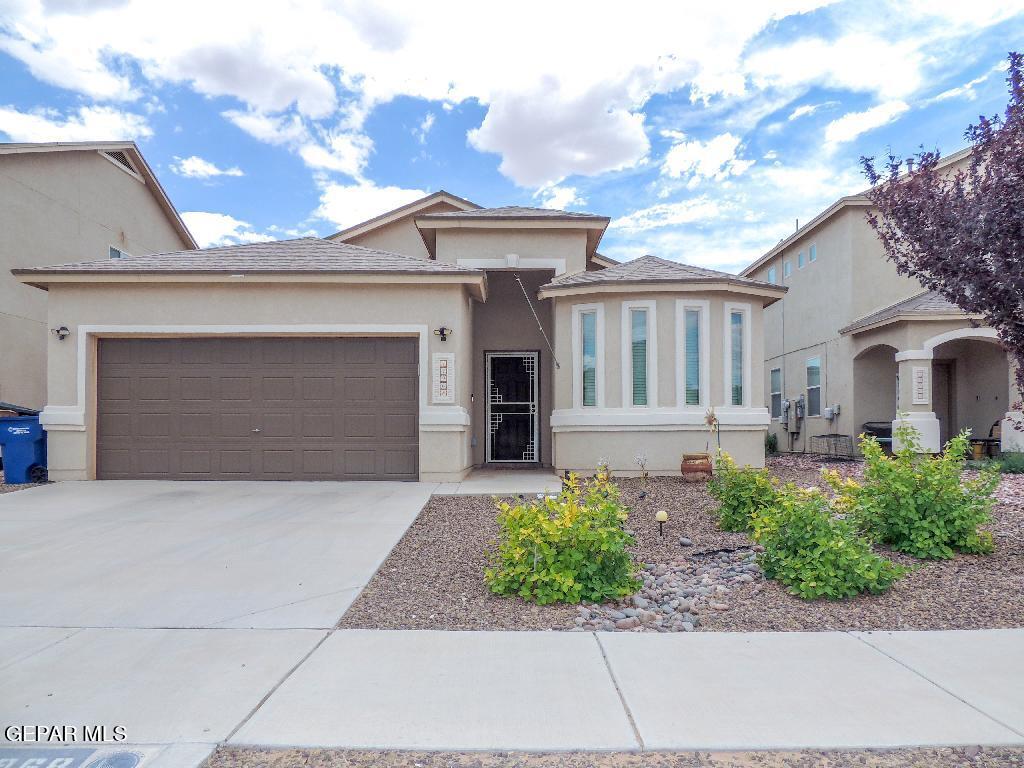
left=824, top=426, right=999, bottom=560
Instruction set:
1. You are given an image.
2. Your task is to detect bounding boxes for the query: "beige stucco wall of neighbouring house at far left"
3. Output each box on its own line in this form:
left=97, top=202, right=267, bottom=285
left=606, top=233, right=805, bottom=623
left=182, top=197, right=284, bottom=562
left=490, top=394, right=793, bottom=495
left=0, top=151, right=187, bottom=409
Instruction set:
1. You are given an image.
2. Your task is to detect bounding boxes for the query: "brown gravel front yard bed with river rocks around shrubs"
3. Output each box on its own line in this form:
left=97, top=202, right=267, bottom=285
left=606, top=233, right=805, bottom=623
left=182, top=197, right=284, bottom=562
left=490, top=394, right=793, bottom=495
left=340, top=455, right=1024, bottom=632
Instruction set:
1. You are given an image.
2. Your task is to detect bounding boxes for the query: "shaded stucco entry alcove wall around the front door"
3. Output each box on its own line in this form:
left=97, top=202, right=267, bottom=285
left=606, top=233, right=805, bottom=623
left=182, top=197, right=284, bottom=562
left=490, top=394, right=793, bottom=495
left=470, top=269, right=554, bottom=466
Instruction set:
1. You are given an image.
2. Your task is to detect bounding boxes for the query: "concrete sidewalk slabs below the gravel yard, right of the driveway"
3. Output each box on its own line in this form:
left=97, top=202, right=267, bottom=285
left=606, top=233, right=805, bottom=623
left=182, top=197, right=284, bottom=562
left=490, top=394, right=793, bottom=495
left=229, top=630, right=1024, bottom=751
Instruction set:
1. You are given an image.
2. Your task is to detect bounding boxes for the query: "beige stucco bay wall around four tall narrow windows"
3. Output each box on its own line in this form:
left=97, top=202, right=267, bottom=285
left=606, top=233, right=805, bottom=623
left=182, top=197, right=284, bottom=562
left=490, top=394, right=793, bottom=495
left=552, top=292, right=765, bottom=474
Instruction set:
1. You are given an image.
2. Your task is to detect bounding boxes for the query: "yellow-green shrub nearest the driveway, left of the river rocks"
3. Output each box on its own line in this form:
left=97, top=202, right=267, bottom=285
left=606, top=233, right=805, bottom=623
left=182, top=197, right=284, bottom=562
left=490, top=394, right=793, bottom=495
left=484, top=472, right=642, bottom=605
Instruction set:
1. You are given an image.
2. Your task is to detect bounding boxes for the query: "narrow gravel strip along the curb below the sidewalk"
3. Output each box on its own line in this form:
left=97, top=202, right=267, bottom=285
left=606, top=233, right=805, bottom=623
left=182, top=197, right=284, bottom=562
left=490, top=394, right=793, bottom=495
left=205, top=746, right=1024, bottom=768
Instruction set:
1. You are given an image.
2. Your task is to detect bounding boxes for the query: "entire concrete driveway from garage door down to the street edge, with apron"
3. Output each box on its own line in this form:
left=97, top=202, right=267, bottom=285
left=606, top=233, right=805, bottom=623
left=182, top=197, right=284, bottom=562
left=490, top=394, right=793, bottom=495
left=0, top=481, right=435, bottom=768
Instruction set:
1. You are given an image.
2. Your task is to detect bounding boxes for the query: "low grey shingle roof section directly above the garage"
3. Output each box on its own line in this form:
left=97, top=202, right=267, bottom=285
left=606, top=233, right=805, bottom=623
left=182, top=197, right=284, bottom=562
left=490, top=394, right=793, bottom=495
left=11, top=238, right=482, bottom=274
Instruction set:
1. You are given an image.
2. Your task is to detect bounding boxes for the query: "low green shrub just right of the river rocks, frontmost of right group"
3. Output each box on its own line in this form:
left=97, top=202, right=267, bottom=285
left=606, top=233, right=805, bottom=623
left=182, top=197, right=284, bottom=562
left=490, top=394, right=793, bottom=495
left=753, top=483, right=906, bottom=600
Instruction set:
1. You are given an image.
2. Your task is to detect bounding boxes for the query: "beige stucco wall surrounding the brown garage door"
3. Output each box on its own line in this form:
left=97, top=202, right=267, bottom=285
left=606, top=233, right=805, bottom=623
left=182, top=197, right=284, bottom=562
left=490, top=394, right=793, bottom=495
left=36, top=283, right=472, bottom=479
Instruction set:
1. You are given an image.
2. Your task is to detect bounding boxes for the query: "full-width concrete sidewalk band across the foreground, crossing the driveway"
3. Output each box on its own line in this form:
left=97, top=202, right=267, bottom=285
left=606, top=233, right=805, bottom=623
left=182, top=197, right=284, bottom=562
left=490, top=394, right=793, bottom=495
left=0, top=628, right=1024, bottom=768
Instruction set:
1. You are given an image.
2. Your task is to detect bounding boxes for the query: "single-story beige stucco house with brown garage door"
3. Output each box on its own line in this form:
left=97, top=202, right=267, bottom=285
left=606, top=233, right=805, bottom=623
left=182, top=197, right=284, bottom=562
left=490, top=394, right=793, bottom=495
left=13, top=191, right=785, bottom=480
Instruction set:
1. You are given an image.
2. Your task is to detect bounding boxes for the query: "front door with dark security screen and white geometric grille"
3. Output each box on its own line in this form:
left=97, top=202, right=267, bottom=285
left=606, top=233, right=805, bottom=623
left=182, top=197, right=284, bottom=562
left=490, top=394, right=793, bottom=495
left=485, top=352, right=540, bottom=463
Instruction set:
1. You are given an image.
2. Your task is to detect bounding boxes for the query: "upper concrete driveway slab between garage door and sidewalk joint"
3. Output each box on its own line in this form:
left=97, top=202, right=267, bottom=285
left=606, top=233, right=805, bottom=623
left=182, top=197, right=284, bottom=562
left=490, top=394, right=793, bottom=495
left=0, top=481, right=434, bottom=629
